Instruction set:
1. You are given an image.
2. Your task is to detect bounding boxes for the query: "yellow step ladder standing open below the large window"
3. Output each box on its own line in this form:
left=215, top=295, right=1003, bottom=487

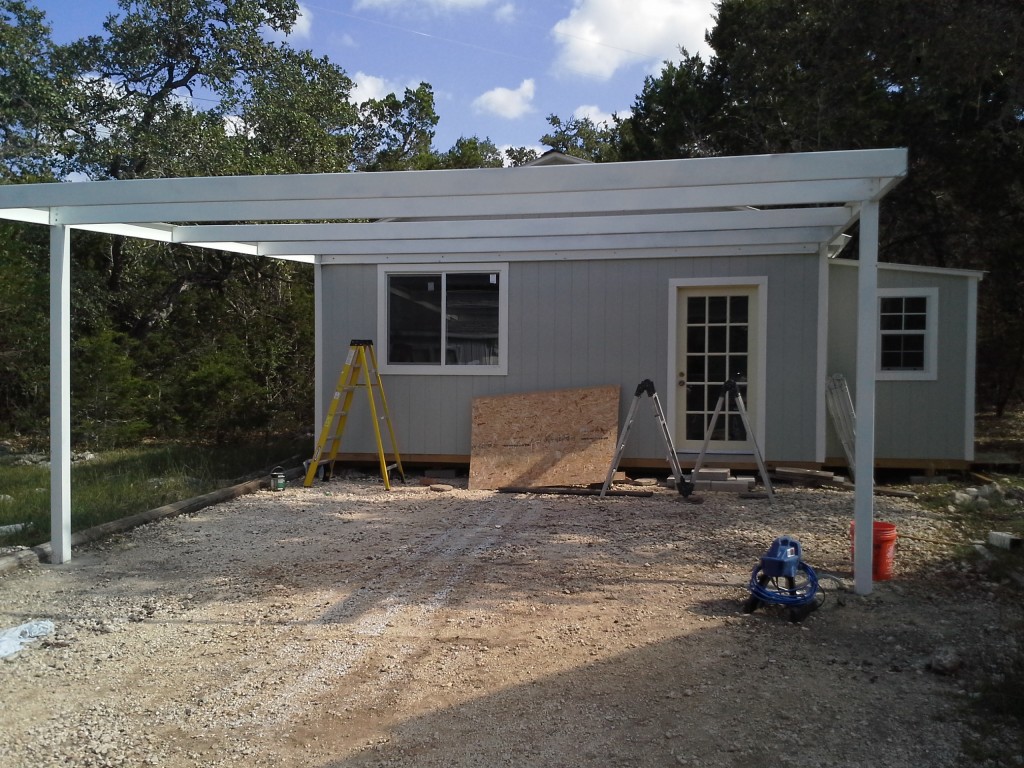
left=303, top=339, right=406, bottom=490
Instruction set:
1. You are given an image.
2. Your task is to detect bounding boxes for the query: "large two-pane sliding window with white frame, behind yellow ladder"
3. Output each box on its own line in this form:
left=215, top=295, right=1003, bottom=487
left=377, top=264, right=508, bottom=376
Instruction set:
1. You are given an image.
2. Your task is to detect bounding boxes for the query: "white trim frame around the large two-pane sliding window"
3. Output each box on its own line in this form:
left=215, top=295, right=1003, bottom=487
left=377, top=262, right=509, bottom=376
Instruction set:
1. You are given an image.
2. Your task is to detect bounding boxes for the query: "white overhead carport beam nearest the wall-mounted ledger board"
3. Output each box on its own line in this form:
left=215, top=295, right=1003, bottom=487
left=259, top=227, right=831, bottom=256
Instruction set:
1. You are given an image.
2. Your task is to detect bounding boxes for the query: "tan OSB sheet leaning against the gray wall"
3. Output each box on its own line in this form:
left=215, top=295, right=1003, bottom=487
left=469, top=386, right=620, bottom=490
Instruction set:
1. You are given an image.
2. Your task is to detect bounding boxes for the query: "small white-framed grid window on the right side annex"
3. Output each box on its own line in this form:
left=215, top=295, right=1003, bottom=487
left=878, top=288, right=939, bottom=380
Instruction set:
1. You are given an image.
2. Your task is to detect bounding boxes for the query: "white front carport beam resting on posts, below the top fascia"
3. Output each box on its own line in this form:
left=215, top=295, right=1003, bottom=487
left=52, top=179, right=878, bottom=225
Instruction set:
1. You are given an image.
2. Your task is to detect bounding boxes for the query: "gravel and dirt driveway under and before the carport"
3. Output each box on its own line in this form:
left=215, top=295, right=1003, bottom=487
left=0, top=478, right=1020, bottom=768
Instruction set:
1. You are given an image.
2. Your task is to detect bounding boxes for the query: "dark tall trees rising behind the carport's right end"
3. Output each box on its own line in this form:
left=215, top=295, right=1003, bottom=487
left=621, top=0, right=1024, bottom=411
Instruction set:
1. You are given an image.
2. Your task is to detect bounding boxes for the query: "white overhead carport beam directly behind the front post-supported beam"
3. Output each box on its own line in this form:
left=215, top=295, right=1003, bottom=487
left=174, top=207, right=850, bottom=243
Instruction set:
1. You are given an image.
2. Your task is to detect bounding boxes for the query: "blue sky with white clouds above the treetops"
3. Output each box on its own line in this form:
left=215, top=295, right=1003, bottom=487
left=34, top=0, right=713, bottom=156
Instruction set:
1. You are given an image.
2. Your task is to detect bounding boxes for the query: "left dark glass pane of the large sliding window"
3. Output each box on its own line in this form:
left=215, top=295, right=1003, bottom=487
left=387, top=274, right=441, bottom=365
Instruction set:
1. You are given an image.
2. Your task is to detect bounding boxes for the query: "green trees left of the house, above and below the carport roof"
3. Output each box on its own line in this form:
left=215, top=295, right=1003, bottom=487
left=0, top=0, right=509, bottom=446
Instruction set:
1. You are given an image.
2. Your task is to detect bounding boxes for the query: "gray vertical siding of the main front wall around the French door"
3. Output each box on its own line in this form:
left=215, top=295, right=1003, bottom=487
left=322, top=253, right=831, bottom=461
